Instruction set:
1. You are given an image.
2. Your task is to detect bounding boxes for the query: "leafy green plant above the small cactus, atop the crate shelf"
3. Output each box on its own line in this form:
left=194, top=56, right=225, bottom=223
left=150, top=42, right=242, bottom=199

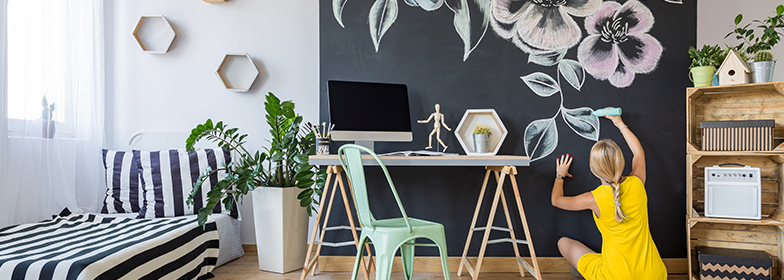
left=724, top=5, right=784, bottom=58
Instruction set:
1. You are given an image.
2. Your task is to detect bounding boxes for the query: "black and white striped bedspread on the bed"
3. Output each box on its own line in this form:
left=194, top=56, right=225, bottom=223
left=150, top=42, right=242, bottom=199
left=0, top=214, right=218, bottom=280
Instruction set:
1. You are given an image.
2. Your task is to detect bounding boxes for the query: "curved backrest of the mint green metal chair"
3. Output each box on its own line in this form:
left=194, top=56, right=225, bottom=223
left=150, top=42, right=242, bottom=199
left=338, top=144, right=412, bottom=232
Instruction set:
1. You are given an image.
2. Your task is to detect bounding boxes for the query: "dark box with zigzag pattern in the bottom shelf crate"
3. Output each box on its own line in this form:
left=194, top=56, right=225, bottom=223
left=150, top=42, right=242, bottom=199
left=697, top=247, right=773, bottom=280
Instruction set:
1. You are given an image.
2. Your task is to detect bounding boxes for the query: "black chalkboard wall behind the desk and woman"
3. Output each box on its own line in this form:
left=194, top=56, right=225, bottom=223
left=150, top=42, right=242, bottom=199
left=319, top=0, right=697, bottom=258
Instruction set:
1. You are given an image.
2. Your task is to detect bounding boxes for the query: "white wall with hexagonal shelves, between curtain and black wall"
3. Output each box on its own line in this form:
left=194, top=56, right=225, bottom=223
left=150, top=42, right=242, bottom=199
left=106, top=0, right=319, bottom=244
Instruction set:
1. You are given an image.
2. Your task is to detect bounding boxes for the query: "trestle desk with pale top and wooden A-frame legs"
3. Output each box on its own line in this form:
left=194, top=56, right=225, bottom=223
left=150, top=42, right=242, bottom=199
left=300, top=154, right=542, bottom=280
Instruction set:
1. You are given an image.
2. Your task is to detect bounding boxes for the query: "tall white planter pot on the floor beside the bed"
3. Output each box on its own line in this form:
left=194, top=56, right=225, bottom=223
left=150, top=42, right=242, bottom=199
left=253, top=187, right=308, bottom=273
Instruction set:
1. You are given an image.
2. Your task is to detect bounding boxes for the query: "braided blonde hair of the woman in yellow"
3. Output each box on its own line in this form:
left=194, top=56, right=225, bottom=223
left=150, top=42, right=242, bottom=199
left=590, top=139, right=626, bottom=223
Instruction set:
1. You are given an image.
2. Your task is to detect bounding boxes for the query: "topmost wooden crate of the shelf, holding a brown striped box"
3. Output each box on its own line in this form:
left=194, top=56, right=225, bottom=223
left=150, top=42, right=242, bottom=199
left=686, top=82, right=784, bottom=153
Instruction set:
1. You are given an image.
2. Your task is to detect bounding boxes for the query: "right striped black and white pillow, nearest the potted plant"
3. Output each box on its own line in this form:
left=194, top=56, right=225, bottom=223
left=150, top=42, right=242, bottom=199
left=138, top=149, right=238, bottom=218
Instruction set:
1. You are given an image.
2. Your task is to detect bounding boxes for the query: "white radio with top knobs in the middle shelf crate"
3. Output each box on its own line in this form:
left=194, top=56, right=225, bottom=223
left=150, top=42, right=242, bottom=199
left=705, top=166, right=762, bottom=220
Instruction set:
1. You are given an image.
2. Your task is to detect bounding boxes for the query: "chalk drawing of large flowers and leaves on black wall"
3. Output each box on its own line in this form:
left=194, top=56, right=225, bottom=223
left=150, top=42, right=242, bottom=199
left=332, top=0, right=663, bottom=161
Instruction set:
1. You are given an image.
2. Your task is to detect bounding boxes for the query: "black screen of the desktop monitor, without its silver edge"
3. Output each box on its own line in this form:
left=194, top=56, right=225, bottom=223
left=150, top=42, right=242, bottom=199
left=328, top=81, right=411, bottom=132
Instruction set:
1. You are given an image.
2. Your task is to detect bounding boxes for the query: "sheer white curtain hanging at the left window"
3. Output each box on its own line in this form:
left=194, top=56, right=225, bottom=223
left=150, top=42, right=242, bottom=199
left=0, top=0, right=104, bottom=228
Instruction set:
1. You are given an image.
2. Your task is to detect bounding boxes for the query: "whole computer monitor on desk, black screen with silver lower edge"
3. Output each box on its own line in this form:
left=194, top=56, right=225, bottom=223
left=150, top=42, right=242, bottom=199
left=327, top=81, right=413, bottom=152
